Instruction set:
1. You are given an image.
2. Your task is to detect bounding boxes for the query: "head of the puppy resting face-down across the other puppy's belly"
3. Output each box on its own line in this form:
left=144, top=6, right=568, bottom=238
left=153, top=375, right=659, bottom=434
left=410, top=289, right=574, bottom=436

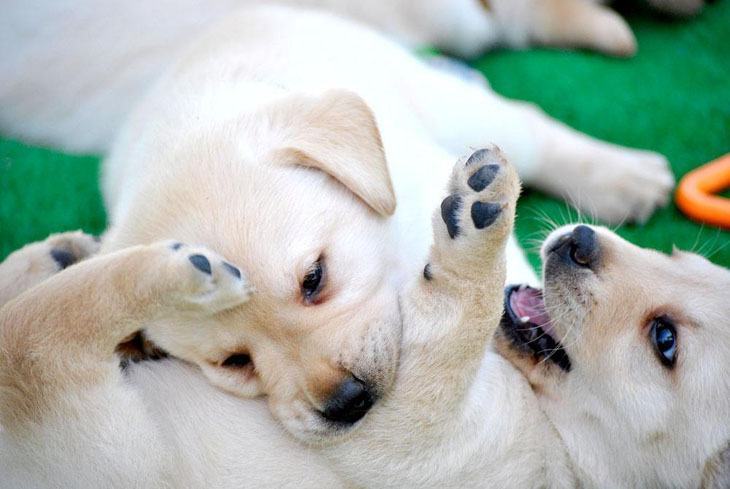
left=138, top=88, right=400, bottom=442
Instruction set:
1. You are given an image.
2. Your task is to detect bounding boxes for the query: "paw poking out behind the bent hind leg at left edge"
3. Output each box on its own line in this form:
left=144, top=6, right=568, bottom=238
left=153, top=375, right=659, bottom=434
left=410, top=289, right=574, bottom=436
left=0, top=231, right=99, bottom=306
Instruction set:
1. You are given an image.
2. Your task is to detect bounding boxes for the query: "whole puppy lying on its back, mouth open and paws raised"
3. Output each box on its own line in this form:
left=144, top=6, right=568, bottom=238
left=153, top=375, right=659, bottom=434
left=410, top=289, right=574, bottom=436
left=0, top=154, right=730, bottom=488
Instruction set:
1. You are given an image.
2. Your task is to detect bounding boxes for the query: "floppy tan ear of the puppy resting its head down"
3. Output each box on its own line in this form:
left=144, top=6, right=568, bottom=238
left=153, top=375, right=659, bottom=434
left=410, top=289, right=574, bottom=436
left=268, top=90, right=395, bottom=217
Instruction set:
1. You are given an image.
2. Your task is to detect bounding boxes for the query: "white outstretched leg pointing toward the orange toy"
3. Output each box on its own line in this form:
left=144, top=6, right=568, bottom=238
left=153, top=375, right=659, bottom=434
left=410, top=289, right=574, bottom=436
left=403, top=67, right=674, bottom=223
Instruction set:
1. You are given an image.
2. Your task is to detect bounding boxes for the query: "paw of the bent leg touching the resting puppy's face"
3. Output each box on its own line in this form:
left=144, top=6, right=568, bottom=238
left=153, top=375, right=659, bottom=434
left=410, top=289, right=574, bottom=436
left=157, top=242, right=253, bottom=314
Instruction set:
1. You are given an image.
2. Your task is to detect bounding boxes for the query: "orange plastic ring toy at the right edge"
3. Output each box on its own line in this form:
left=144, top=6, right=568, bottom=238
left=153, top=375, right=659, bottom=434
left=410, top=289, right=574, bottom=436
left=676, top=153, right=730, bottom=229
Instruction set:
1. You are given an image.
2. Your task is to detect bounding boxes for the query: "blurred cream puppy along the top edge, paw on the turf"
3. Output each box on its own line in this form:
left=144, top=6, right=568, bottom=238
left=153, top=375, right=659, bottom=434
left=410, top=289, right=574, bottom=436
left=268, top=0, right=704, bottom=57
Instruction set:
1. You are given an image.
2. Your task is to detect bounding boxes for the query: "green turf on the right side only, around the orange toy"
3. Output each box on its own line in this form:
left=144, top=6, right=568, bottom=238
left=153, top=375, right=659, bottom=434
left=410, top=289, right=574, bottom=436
left=474, top=2, right=730, bottom=266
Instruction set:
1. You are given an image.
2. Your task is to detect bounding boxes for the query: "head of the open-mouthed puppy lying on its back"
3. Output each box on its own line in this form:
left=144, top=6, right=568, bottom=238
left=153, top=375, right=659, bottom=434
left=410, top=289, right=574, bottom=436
left=498, top=225, right=730, bottom=487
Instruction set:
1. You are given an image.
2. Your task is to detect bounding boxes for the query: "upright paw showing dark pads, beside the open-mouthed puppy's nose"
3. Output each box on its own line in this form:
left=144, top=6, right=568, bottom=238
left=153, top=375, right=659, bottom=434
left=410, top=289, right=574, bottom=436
left=424, top=146, right=520, bottom=278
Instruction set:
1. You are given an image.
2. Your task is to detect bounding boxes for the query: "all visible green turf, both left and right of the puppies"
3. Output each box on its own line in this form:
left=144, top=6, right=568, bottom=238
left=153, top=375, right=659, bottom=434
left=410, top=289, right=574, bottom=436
left=0, top=1, right=730, bottom=266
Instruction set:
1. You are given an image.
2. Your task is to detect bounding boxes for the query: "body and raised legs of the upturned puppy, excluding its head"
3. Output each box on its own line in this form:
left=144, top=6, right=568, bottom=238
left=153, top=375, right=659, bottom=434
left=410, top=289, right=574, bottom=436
left=0, top=150, right=574, bottom=488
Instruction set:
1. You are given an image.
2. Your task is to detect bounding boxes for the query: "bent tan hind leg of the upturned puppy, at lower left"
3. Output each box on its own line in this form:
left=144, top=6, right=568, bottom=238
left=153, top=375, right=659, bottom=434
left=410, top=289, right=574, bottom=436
left=0, top=243, right=249, bottom=487
